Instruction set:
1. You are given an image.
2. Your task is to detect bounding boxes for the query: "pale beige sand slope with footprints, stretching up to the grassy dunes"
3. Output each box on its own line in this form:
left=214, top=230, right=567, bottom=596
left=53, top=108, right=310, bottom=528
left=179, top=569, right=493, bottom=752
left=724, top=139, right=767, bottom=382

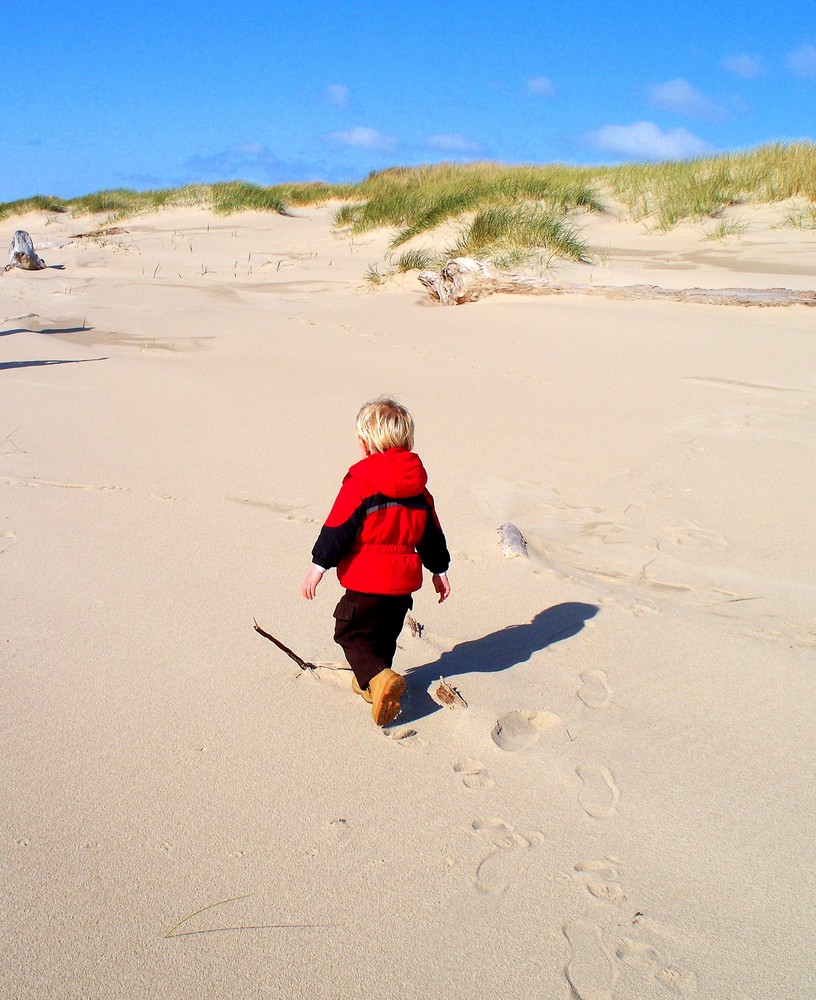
left=0, top=208, right=816, bottom=1000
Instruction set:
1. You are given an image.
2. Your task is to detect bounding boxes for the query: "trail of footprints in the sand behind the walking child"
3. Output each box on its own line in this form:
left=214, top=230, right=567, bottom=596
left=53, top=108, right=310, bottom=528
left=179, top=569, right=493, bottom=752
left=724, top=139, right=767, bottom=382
left=444, top=656, right=697, bottom=1000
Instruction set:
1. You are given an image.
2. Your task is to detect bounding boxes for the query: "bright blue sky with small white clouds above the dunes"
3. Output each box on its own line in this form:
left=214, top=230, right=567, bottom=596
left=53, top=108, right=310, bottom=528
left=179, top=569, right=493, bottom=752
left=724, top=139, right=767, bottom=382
left=0, top=0, right=816, bottom=201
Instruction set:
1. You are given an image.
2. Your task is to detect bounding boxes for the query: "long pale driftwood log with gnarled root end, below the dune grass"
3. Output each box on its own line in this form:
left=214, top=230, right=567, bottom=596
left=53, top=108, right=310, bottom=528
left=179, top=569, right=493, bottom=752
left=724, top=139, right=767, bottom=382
left=419, top=257, right=816, bottom=306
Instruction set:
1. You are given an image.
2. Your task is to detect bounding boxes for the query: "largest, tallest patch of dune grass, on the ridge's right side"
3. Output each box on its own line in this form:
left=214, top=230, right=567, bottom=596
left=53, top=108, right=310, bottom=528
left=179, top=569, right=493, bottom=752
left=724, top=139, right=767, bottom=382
left=335, top=142, right=816, bottom=271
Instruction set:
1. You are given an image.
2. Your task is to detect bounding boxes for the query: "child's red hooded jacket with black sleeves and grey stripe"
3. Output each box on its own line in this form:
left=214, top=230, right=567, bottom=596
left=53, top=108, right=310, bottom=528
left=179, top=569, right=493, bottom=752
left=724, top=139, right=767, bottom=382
left=312, top=448, right=450, bottom=594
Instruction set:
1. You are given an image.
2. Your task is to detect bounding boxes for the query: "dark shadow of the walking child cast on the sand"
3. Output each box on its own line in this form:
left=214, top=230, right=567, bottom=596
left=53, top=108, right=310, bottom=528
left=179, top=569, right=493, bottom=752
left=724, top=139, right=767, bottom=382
left=399, top=601, right=599, bottom=722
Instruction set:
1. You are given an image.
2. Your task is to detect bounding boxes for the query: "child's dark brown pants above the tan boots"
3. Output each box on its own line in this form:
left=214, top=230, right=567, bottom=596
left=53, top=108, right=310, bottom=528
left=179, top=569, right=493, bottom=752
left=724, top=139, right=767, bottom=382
left=334, top=590, right=414, bottom=688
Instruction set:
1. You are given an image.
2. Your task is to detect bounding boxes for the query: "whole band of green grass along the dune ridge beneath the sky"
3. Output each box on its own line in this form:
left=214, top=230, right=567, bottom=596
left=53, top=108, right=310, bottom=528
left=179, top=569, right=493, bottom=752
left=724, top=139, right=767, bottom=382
left=0, top=142, right=816, bottom=274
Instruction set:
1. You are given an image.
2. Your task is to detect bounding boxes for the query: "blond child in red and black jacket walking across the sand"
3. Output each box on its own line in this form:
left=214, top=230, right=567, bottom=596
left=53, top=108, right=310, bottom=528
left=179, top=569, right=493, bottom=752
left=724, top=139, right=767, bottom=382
left=301, top=396, right=450, bottom=726
